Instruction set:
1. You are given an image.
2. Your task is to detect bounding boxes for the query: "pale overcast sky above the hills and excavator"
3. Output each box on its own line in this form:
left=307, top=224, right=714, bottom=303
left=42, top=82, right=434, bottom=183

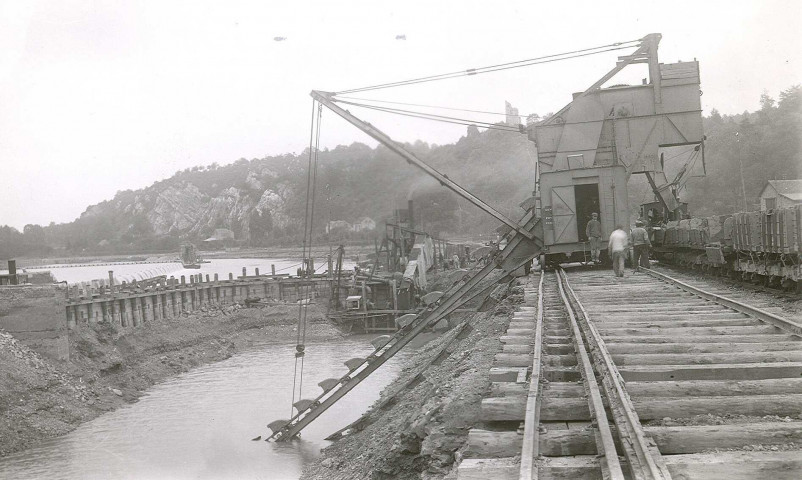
left=0, top=0, right=802, bottom=229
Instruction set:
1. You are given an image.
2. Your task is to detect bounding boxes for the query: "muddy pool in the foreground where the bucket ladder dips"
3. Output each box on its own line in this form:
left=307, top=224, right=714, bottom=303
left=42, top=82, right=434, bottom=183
left=0, top=336, right=414, bottom=480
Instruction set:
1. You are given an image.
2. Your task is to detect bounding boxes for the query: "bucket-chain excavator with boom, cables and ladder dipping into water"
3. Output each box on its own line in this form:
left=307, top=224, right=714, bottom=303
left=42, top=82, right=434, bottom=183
left=267, top=34, right=703, bottom=441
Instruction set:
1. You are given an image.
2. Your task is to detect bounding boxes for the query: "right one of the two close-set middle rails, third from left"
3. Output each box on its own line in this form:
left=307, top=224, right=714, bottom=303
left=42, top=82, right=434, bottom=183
left=558, top=269, right=671, bottom=480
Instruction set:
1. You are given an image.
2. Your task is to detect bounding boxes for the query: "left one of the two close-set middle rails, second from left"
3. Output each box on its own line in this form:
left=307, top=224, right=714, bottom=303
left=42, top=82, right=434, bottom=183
left=552, top=270, right=625, bottom=480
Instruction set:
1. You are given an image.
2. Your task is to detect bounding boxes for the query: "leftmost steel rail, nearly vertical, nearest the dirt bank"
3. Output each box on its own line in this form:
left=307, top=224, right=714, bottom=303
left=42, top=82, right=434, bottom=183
left=518, top=271, right=546, bottom=480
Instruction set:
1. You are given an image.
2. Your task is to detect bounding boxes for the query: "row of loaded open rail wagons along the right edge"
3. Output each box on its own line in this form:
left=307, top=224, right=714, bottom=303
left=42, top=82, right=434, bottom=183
left=643, top=205, right=802, bottom=292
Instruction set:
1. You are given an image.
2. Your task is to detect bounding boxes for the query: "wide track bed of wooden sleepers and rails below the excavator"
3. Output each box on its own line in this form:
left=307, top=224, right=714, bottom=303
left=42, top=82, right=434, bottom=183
left=457, top=271, right=802, bottom=480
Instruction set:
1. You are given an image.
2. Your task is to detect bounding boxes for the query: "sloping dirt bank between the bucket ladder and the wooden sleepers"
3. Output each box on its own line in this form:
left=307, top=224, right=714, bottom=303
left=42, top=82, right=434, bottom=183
left=301, top=287, right=523, bottom=480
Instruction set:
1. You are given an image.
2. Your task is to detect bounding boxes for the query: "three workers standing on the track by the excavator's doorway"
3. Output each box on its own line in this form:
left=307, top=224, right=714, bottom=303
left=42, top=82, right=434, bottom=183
left=585, top=213, right=652, bottom=277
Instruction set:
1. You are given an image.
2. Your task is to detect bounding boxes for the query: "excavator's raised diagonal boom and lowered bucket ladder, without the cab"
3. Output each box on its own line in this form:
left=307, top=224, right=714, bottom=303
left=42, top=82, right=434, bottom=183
left=266, top=91, right=543, bottom=441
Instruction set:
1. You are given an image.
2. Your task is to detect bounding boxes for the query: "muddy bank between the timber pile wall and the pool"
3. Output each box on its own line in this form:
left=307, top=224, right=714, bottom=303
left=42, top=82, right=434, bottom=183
left=0, top=304, right=342, bottom=456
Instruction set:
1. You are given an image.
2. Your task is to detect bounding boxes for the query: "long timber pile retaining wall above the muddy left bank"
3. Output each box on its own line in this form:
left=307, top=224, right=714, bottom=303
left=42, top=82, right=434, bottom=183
left=0, top=274, right=340, bottom=361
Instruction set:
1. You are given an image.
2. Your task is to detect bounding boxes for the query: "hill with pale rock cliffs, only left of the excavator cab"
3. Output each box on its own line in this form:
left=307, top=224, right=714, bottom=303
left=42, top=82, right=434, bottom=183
left=26, top=127, right=535, bottom=253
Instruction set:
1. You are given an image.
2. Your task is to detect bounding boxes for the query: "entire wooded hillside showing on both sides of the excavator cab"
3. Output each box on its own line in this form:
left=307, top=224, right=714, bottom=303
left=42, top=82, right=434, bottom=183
left=0, top=85, right=802, bottom=258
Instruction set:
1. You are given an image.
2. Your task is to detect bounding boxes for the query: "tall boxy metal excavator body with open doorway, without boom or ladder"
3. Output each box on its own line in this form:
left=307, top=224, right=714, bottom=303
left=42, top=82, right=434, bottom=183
left=528, top=34, right=704, bottom=265
